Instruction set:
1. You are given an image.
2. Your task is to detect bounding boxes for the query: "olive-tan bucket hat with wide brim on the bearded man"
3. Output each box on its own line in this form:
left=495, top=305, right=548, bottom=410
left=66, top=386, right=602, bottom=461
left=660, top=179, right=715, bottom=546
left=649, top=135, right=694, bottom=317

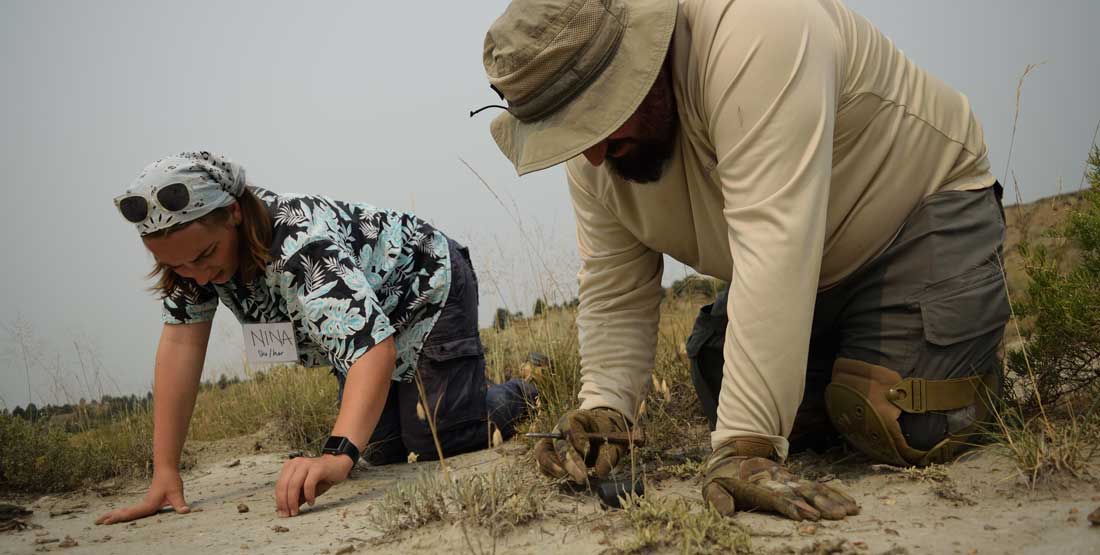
left=483, top=0, right=678, bottom=175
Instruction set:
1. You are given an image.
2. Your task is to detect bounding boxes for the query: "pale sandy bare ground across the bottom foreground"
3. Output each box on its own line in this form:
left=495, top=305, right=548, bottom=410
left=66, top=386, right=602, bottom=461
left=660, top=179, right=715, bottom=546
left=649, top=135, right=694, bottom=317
left=0, top=444, right=1100, bottom=555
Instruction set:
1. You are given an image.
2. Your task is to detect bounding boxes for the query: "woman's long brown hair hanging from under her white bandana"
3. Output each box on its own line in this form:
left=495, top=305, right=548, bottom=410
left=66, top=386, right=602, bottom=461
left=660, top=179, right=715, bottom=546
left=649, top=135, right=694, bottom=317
left=145, top=187, right=272, bottom=298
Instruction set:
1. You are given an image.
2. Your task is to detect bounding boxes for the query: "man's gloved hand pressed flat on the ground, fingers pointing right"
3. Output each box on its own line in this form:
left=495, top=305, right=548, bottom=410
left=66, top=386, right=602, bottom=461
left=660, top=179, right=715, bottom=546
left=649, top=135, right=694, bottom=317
left=703, top=439, right=859, bottom=520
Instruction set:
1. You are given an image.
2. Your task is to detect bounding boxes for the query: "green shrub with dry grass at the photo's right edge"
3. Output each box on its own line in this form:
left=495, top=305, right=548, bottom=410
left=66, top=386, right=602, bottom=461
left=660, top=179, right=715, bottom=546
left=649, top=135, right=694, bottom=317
left=986, top=145, right=1100, bottom=487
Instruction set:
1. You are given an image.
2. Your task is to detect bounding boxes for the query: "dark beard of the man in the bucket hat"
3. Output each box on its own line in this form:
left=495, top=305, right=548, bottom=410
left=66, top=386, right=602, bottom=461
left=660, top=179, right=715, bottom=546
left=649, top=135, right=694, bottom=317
left=607, top=74, right=680, bottom=184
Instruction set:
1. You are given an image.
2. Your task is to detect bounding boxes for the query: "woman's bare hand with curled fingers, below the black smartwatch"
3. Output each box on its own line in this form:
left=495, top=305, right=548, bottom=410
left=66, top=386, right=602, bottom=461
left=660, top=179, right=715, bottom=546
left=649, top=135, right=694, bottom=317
left=275, top=455, right=354, bottom=517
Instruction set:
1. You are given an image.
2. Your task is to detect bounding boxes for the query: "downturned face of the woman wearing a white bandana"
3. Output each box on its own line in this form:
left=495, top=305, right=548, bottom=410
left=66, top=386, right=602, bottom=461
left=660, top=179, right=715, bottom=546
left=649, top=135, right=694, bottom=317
left=142, top=203, right=241, bottom=286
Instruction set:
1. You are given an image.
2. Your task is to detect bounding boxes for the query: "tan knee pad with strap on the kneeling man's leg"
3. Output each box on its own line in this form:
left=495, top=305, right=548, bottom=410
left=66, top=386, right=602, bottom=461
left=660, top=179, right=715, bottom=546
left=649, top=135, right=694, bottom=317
left=825, top=358, right=998, bottom=466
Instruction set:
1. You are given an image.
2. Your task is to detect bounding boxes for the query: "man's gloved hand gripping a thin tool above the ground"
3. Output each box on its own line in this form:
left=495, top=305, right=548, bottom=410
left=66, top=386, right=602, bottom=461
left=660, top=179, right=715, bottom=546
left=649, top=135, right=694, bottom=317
left=535, top=409, right=629, bottom=485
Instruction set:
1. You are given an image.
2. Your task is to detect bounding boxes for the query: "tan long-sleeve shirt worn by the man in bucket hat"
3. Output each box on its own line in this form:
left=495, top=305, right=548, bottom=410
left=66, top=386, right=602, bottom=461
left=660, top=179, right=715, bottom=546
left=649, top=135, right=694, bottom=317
left=567, top=0, right=993, bottom=456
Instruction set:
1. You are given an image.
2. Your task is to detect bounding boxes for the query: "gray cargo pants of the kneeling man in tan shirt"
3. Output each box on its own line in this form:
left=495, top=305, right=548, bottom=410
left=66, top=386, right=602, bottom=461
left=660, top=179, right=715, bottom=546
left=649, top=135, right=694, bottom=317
left=688, top=185, right=1010, bottom=452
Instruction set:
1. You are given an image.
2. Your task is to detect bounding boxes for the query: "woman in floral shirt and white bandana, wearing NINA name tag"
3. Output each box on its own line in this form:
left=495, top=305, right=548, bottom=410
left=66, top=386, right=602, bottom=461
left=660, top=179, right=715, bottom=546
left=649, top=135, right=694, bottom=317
left=96, top=152, right=535, bottom=524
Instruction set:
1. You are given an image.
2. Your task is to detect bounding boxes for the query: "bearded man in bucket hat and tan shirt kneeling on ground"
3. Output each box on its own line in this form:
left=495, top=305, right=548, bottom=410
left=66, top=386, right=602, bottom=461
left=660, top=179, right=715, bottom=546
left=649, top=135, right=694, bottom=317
left=484, top=0, right=1009, bottom=520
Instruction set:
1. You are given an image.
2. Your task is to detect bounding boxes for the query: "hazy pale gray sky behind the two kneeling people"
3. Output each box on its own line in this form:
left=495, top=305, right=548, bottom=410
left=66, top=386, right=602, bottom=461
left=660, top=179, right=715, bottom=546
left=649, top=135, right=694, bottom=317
left=0, top=0, right=1100, bottom=408
